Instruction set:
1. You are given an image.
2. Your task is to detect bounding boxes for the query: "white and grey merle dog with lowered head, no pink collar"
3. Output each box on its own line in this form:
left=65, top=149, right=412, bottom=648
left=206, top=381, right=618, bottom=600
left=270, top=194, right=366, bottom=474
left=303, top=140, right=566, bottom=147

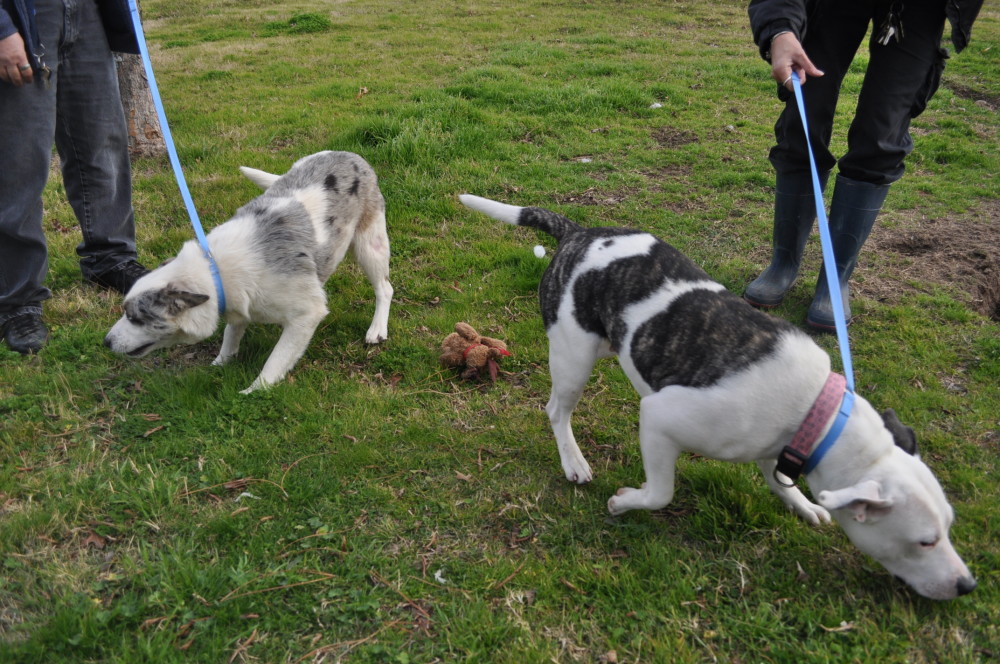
left=104, top=152, right=393, bottom=393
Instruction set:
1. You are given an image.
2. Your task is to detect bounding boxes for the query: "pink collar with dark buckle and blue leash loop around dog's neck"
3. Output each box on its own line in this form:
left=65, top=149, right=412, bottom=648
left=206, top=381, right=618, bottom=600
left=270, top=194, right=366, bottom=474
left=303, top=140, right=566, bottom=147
left=774, top=372, right=854, bottom=487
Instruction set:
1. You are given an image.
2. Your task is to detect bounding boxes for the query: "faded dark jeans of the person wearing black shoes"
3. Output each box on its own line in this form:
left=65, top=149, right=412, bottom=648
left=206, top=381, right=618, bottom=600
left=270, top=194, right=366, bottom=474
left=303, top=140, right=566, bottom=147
left=0, top=0, right=136, bottom=324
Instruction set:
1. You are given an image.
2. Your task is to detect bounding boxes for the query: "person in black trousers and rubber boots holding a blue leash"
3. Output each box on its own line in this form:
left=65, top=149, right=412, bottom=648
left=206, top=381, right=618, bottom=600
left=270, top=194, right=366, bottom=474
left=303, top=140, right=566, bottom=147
left=744, top=0, right=983, bottom=331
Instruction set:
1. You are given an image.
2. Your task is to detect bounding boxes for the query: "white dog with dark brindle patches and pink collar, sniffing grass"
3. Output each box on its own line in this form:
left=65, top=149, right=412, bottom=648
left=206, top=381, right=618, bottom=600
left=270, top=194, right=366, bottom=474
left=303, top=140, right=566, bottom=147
left=460, top=194, right=976, bottom=599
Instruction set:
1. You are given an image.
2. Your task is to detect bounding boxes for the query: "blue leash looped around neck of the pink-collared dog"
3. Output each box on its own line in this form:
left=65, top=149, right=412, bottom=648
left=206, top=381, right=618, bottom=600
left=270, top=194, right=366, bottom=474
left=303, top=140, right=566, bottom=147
left=792, top=71, right=854, bottom=474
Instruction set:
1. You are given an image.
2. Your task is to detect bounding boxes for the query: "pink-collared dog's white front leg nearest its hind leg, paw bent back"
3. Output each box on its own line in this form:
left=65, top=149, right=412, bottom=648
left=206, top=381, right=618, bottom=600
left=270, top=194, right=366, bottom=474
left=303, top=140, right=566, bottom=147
left=608, top=392, right=681, bottom=516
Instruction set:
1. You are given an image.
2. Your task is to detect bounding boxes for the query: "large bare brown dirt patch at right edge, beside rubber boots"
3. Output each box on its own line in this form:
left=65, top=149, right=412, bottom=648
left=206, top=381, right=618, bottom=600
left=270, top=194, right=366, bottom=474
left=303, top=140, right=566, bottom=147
left=852, top=200, right=1000, bottom=321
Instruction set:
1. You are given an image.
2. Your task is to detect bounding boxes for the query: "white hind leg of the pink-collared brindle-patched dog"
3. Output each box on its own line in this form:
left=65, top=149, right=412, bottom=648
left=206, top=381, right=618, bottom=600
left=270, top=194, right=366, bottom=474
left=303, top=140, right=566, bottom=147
left=545, top=324, right=607, bottom=484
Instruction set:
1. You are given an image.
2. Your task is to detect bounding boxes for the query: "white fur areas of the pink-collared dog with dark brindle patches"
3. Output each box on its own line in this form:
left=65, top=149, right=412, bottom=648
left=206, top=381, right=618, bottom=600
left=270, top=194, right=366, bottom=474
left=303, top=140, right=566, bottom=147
left=460, top=194, right=975, bottom=599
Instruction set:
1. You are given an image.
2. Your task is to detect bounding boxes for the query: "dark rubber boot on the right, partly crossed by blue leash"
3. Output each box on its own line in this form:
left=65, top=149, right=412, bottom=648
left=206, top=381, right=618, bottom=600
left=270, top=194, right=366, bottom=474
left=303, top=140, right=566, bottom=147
left=806, top=175, right=889, bottom=332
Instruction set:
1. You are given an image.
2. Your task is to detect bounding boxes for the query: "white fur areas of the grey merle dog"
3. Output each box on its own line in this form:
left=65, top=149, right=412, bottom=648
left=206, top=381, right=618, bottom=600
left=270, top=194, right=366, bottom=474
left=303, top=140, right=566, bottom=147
left=105, top=153, right=393, bottom=393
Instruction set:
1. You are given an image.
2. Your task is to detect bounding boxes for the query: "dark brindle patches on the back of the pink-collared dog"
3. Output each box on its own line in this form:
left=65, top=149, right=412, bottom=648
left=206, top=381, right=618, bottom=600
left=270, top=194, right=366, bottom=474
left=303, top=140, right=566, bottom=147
left=536, top=224, right=795, bottom=390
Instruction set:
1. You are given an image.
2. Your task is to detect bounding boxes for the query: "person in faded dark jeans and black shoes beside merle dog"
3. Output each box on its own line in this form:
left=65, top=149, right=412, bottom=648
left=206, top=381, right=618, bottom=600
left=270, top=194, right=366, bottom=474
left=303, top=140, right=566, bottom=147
left=0, top=0, right=147, bottom=353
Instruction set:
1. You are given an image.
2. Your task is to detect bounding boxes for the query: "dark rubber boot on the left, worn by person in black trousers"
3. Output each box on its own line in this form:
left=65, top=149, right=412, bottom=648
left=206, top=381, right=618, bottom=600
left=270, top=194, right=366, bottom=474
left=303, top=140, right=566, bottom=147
left=743, top=172, right=830, bottom=308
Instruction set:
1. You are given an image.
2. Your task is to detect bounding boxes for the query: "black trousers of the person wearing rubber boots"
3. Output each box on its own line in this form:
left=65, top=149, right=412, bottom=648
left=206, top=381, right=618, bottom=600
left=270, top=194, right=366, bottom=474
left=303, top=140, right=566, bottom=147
left=770, top=0, right=948, bottom=185
